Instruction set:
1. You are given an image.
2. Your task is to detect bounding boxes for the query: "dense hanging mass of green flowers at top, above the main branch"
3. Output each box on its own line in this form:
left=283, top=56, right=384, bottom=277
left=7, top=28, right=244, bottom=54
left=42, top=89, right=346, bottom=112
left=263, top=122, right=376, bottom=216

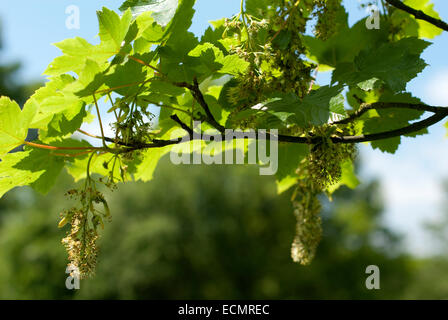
left=223, top=0, right=344, bottom=128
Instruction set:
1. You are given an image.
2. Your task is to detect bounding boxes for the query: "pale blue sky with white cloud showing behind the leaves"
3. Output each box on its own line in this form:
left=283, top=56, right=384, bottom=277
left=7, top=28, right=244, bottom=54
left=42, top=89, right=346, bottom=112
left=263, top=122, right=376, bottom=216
left=0, top=0, right=448, bottom=254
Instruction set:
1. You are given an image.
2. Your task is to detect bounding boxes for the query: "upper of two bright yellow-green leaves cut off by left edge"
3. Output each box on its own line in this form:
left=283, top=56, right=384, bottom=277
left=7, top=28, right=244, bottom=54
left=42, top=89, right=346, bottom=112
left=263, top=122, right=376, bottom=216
left=0, top=97, right=37, bottom=157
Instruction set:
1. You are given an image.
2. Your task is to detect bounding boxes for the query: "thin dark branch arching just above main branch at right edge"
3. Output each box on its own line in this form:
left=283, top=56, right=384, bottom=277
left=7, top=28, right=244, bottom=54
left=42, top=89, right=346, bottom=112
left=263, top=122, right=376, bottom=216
left=331, top=102, right=448, bottom=124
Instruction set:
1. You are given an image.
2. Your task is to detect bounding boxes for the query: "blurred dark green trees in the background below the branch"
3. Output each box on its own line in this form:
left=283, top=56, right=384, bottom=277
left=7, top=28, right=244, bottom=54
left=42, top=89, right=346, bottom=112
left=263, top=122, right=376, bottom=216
left=0, top=159, right=448, bottom=299
